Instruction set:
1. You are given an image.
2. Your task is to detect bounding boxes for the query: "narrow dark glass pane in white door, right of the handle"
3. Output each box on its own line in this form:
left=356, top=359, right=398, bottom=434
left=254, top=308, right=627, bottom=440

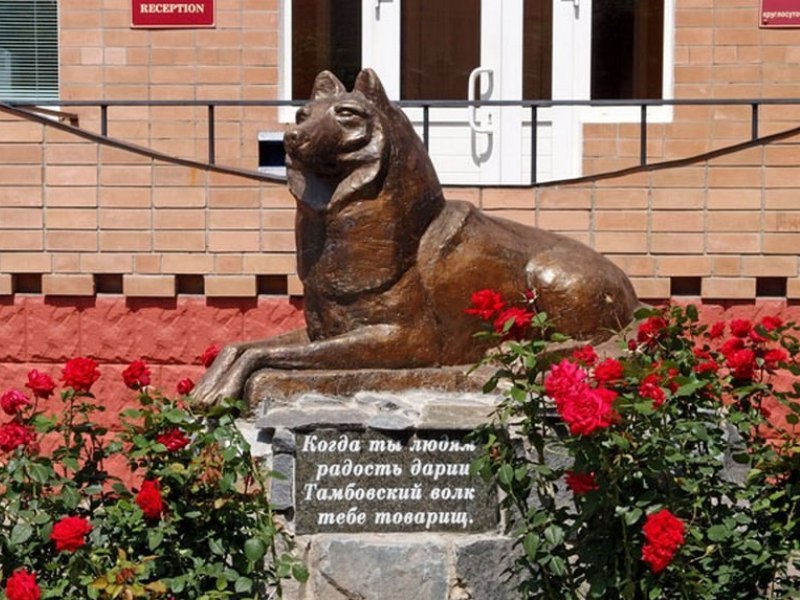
left=522, top=0, right=553, bottom=100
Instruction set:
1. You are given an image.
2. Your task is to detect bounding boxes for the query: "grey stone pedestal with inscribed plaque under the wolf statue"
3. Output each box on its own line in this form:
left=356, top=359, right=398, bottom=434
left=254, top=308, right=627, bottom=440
left=245, top=390, right=516, bottom=600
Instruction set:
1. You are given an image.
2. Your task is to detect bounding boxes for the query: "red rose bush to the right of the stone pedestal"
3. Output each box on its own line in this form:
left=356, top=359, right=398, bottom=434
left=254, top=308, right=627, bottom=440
left=468, top=290, right=800, bottom=600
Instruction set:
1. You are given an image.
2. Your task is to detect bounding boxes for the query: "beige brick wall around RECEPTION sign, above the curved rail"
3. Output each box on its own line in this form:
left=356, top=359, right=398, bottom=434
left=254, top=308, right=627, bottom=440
left=55, top=0, right=282, bottom=171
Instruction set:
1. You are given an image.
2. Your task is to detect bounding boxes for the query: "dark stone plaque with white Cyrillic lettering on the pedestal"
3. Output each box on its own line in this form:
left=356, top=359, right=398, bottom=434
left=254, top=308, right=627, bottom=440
left=295, top=429, right=498, bottom=534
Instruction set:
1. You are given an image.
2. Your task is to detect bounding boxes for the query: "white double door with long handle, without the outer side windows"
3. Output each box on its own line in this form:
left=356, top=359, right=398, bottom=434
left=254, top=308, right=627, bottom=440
left=362, top=0, right=589, bottom=185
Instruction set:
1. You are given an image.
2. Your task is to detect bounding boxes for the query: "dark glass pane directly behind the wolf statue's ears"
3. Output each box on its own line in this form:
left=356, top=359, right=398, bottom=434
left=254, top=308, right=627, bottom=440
left=292, top=0, right=361, bottom=100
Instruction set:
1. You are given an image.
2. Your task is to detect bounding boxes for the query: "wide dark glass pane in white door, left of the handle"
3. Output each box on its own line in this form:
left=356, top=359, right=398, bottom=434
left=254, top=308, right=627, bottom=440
left=400, top=0, right=481, bottom=100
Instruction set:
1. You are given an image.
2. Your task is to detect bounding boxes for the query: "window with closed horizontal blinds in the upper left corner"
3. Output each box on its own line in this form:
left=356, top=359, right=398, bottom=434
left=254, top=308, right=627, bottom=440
left=0, top=0, right=58, bottom=102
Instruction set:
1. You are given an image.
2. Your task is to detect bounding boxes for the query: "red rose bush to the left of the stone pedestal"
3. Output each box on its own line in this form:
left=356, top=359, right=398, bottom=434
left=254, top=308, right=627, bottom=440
left=0, top=357, right=307, bottom=600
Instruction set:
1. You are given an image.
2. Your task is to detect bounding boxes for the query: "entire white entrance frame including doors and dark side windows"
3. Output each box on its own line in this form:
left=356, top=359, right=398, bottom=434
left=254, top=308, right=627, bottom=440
left=281, top=0, right=674, bottom=185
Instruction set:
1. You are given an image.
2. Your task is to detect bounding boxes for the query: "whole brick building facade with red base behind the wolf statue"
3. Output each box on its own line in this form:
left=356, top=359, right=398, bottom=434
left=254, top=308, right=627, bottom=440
left=0, top=0, right=800, bottom=392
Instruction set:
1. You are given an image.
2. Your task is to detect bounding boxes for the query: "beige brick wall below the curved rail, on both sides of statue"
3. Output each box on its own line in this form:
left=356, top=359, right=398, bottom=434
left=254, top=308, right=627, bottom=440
left=0, top=105, right=800, bottom=299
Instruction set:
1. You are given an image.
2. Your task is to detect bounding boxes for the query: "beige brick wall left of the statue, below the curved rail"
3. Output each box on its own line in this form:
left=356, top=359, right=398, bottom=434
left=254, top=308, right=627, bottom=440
left=0, top=108, right=300, bottom=297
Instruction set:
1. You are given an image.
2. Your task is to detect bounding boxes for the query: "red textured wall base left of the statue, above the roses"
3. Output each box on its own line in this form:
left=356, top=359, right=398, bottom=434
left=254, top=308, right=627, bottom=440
left=0, top=295, right=304, bottom=424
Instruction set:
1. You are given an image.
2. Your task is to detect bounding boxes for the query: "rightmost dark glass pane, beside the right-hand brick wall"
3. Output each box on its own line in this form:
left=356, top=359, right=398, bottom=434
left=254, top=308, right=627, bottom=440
left=592, top=0, right=664, bottom=99
